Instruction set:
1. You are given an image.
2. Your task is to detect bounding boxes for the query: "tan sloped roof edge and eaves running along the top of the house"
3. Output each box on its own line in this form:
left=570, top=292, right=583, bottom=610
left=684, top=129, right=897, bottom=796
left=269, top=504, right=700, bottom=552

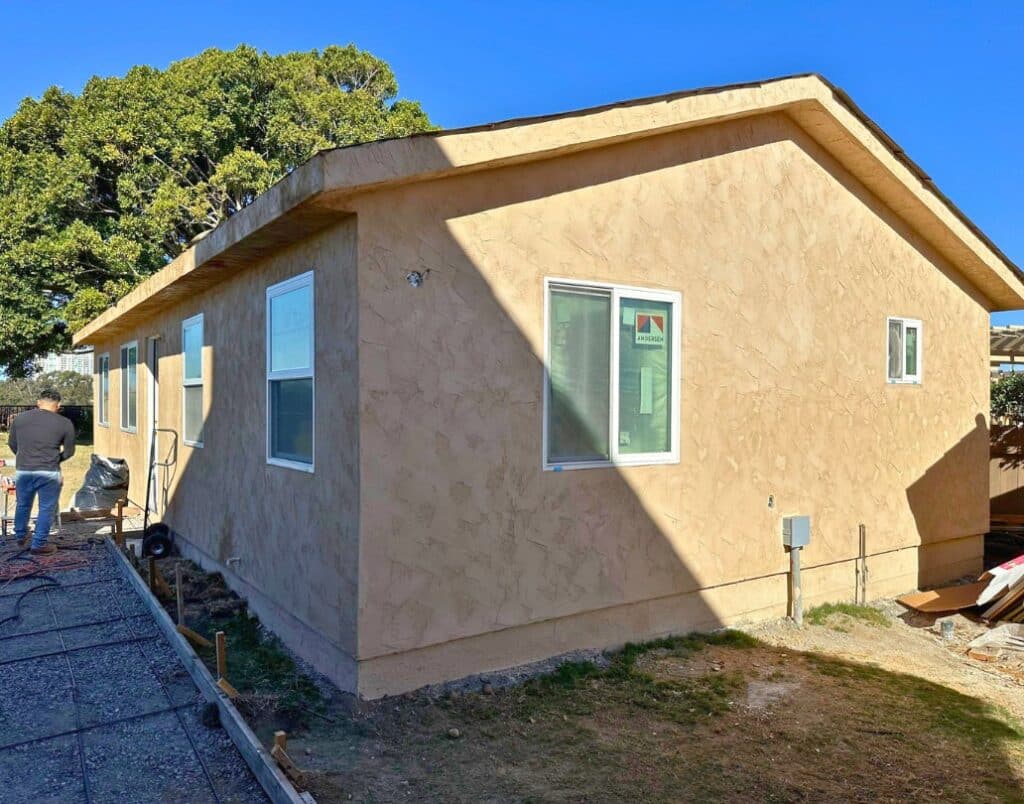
left=74, top=73, right=1024, bottom=345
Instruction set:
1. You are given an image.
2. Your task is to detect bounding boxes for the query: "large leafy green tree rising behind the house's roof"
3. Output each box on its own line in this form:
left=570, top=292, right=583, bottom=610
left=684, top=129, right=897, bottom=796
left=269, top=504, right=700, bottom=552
left=0, top=45, right=433, bottom=377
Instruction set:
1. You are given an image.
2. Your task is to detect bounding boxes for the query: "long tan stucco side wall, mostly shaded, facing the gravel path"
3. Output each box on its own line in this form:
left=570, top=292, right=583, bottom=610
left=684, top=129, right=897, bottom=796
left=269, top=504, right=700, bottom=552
left=94, top=220, right=358, bottom=685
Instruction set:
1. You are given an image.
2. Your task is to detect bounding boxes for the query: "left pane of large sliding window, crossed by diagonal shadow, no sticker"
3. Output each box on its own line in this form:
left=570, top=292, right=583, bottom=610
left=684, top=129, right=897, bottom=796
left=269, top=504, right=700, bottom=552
left=548, top=288, right=611, bottom=462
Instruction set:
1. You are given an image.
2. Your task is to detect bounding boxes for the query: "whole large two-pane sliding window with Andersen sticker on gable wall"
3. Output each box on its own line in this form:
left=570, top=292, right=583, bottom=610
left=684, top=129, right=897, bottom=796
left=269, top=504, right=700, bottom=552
left=545, top=281, right=680, bottom=469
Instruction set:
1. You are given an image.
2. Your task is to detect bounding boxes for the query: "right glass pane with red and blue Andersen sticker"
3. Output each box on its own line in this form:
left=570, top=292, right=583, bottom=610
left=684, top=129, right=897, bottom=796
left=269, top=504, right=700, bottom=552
left=618, top=298, right=672, bottom=454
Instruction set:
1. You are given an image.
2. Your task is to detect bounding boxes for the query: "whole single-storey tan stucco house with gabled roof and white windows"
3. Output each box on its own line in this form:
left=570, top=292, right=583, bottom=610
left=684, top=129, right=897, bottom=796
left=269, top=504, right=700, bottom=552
left=75, top=76, right=1024, bottom=697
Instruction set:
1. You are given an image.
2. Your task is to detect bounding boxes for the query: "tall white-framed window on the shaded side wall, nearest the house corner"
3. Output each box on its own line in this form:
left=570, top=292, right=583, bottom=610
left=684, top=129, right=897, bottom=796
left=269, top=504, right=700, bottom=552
left=266, top=271, right=314, bottom=471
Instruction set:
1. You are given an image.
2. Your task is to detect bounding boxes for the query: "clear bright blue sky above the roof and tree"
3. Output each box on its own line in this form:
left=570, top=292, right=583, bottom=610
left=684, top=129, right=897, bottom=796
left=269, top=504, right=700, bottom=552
left=0, top=0, right=1024, bottom=324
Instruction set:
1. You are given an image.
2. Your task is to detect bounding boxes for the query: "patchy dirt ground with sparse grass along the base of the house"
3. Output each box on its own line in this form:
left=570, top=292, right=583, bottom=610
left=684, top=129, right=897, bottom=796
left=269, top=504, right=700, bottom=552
left=140, top=558, right=1024, bottom=804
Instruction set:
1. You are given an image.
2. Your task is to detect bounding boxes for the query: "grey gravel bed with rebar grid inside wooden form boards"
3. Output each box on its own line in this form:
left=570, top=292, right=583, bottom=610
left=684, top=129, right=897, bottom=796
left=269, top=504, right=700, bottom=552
left=0, top=545, right=268, bottom=804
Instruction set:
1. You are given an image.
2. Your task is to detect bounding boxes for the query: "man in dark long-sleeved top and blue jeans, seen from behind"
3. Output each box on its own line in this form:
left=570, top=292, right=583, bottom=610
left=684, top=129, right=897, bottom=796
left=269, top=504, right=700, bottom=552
left=7, top=391, right=75, bottom=555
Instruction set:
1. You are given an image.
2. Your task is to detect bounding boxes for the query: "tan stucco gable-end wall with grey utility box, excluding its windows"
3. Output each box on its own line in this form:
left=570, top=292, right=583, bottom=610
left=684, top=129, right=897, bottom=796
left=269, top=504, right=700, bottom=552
left=352, top=115, right=988, bottom=695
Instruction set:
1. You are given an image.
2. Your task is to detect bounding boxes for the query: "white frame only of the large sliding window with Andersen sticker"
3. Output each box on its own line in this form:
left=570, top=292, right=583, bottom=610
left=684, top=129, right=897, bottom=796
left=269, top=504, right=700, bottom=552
left=541, top=277, right=683, bottom=472
